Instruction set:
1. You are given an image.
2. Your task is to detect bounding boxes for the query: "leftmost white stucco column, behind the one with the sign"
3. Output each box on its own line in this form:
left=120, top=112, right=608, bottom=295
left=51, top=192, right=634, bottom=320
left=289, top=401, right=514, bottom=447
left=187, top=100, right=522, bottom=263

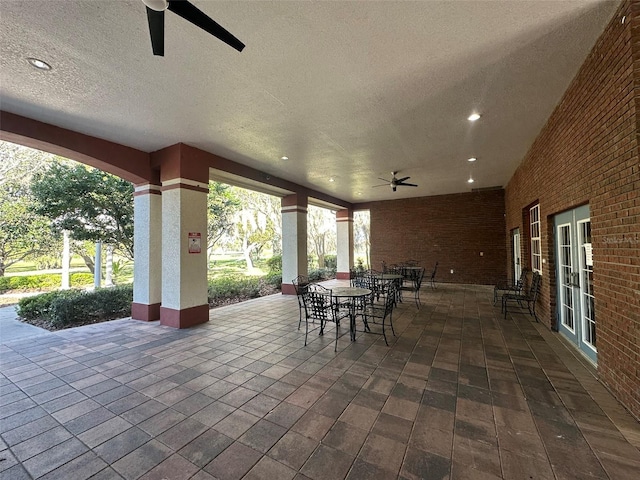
left=131, top=183, right=162, bottom=321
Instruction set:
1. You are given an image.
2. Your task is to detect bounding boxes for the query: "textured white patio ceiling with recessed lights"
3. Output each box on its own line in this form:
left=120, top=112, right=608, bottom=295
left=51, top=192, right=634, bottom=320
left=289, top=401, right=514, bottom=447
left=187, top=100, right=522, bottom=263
left=0, top=0, right=619, bottom=202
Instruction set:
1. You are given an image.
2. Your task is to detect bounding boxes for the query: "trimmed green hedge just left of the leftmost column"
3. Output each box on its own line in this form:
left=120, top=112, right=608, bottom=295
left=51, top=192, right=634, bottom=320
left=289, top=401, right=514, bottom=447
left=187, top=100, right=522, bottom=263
left=18, top=285, right=133, bottom=327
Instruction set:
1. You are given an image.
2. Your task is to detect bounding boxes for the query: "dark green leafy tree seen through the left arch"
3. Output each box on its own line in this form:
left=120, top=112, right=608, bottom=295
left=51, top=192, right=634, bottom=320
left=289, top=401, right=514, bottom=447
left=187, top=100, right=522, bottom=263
left=31, top=162, right=133, bottom=259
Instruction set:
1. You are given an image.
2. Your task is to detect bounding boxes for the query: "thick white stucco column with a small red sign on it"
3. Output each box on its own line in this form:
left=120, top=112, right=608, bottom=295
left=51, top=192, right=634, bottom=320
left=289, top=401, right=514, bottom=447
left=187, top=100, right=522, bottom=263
left=155, top=144, right=209, bottom=328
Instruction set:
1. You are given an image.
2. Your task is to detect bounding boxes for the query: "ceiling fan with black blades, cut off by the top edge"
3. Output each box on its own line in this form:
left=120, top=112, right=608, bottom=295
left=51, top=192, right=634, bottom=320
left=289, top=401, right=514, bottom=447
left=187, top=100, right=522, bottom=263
left=142, top=0, right=244, bottom=57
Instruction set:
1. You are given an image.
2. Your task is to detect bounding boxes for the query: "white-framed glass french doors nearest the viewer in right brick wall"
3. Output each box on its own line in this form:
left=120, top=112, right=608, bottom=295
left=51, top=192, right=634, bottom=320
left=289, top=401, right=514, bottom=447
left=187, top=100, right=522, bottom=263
left=554, top=205, right=597, bottom=363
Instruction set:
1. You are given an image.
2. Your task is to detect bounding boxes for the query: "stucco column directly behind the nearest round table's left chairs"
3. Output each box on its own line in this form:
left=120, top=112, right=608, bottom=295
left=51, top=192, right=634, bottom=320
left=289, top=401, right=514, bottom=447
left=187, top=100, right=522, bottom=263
left=282, top=195, right=308, bottom=295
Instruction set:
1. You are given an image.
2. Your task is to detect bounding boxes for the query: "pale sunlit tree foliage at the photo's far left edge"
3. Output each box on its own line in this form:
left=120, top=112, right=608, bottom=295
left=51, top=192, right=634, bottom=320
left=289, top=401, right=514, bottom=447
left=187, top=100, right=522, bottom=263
left=0, top=182, right=56, bottom=277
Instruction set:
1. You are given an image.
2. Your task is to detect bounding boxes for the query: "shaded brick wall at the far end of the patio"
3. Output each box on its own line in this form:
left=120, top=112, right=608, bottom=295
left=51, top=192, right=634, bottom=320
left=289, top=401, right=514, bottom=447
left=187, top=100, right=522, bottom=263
left=368, top=190, right=506, bottom=284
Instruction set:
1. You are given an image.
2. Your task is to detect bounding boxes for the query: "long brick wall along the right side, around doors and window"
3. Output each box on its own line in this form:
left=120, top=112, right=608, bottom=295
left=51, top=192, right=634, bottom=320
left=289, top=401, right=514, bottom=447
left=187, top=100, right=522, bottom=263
left=505, top=1, right=640, bottom=417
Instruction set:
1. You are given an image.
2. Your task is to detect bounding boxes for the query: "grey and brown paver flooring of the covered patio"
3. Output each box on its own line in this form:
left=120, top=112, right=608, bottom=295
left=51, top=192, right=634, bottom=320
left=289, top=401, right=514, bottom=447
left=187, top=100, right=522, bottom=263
left=0, top=285, right=640, bottom=480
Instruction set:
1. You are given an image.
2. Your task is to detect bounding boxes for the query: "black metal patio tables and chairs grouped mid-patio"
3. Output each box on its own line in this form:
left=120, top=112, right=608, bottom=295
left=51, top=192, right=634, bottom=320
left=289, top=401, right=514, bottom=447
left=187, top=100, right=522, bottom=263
left=292, top=262, right=438, bottom=351
